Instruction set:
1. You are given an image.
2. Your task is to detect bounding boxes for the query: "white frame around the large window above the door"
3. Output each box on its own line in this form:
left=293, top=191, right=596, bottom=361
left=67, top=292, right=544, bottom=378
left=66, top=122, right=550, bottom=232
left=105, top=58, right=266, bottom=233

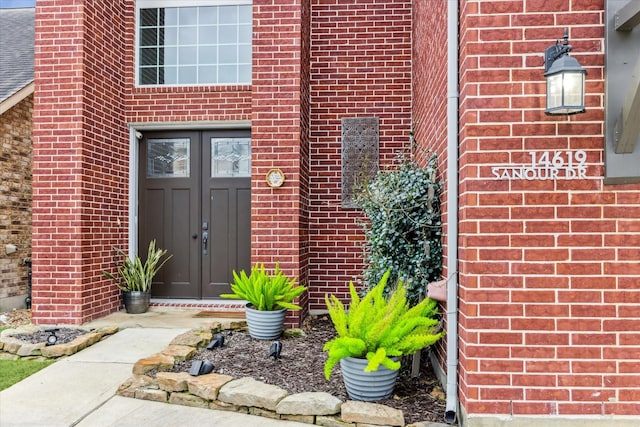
left=134, top=0, right=253, bottom=88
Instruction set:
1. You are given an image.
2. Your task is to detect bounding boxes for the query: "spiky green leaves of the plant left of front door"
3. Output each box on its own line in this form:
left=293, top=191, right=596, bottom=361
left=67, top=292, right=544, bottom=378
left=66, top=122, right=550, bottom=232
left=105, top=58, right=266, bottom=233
left=102, top=240, right=172, bottom=292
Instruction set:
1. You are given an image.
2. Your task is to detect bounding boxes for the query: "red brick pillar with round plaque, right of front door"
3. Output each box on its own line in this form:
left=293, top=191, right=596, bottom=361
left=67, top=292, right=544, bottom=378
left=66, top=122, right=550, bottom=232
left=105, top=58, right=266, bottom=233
left=251, top=0, right=309, bottom=323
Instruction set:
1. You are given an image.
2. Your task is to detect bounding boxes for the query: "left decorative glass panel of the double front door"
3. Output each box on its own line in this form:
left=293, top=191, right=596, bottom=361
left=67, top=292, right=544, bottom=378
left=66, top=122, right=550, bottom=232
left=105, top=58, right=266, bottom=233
left=147, top=138, right=190, bottom=178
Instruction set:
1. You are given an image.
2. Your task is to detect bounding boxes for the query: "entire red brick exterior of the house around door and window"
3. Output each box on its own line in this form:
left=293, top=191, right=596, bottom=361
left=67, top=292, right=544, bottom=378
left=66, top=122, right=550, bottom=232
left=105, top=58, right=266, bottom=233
left=33, top=0, right=640, bottom=426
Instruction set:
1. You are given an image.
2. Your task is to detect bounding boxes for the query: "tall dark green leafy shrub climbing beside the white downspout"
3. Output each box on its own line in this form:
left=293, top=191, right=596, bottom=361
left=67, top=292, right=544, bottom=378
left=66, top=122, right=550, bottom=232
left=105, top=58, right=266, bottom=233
left=356, top=155, right=442, bottom=305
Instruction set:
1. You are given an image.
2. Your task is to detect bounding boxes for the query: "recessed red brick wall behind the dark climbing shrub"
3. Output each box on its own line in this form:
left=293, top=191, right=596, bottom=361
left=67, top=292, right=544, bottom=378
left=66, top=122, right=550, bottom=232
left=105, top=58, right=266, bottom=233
left=309, top=0, right=412, bottom=310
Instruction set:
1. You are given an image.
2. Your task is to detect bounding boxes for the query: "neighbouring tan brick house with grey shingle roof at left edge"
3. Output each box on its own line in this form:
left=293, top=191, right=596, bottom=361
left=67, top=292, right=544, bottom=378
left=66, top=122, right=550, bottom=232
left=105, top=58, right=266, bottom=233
left=0, top=8, right=34, bottom=312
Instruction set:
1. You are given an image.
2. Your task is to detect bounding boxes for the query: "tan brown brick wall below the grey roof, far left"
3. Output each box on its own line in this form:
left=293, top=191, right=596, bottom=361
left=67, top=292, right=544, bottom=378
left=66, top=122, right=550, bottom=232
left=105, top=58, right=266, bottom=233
left=0, top=95, right=33, bottom=311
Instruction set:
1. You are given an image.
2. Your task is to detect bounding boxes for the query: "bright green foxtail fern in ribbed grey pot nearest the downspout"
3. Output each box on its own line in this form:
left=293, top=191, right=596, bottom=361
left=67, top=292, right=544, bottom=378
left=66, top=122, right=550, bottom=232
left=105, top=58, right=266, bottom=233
left=323, top=271, right=444, bottom=401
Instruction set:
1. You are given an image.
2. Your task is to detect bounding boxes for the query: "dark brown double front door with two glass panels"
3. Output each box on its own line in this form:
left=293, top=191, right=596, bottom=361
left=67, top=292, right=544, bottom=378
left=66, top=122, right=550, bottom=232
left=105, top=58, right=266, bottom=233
left=138, top=131, right=251, bottom=299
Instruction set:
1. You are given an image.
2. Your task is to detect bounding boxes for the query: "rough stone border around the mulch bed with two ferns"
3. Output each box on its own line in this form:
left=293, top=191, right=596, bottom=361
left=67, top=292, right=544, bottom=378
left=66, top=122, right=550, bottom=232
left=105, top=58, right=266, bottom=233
left=117, top=321, right=429, bottom=427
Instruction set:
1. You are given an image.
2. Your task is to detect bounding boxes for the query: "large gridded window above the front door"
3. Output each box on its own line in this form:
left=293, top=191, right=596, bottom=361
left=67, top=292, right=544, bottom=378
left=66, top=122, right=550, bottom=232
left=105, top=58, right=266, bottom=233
left=138, top=0, right=252, bottom=85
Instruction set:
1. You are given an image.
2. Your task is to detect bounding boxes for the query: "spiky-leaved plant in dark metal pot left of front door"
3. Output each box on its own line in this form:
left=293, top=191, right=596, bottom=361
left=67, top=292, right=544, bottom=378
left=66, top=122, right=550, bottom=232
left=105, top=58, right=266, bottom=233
left=103, top=240, right=172, bottom=314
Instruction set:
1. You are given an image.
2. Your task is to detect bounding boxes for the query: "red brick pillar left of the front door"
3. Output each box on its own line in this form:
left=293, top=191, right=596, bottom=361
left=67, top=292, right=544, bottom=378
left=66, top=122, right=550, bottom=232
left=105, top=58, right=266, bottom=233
left=33, top=1, right=128, bottom=324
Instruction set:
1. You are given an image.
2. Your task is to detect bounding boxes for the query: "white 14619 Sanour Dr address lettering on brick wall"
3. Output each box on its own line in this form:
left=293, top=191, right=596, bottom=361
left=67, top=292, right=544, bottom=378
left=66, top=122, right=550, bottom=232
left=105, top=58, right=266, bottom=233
left=491, top=150, right=587, bottom=181
